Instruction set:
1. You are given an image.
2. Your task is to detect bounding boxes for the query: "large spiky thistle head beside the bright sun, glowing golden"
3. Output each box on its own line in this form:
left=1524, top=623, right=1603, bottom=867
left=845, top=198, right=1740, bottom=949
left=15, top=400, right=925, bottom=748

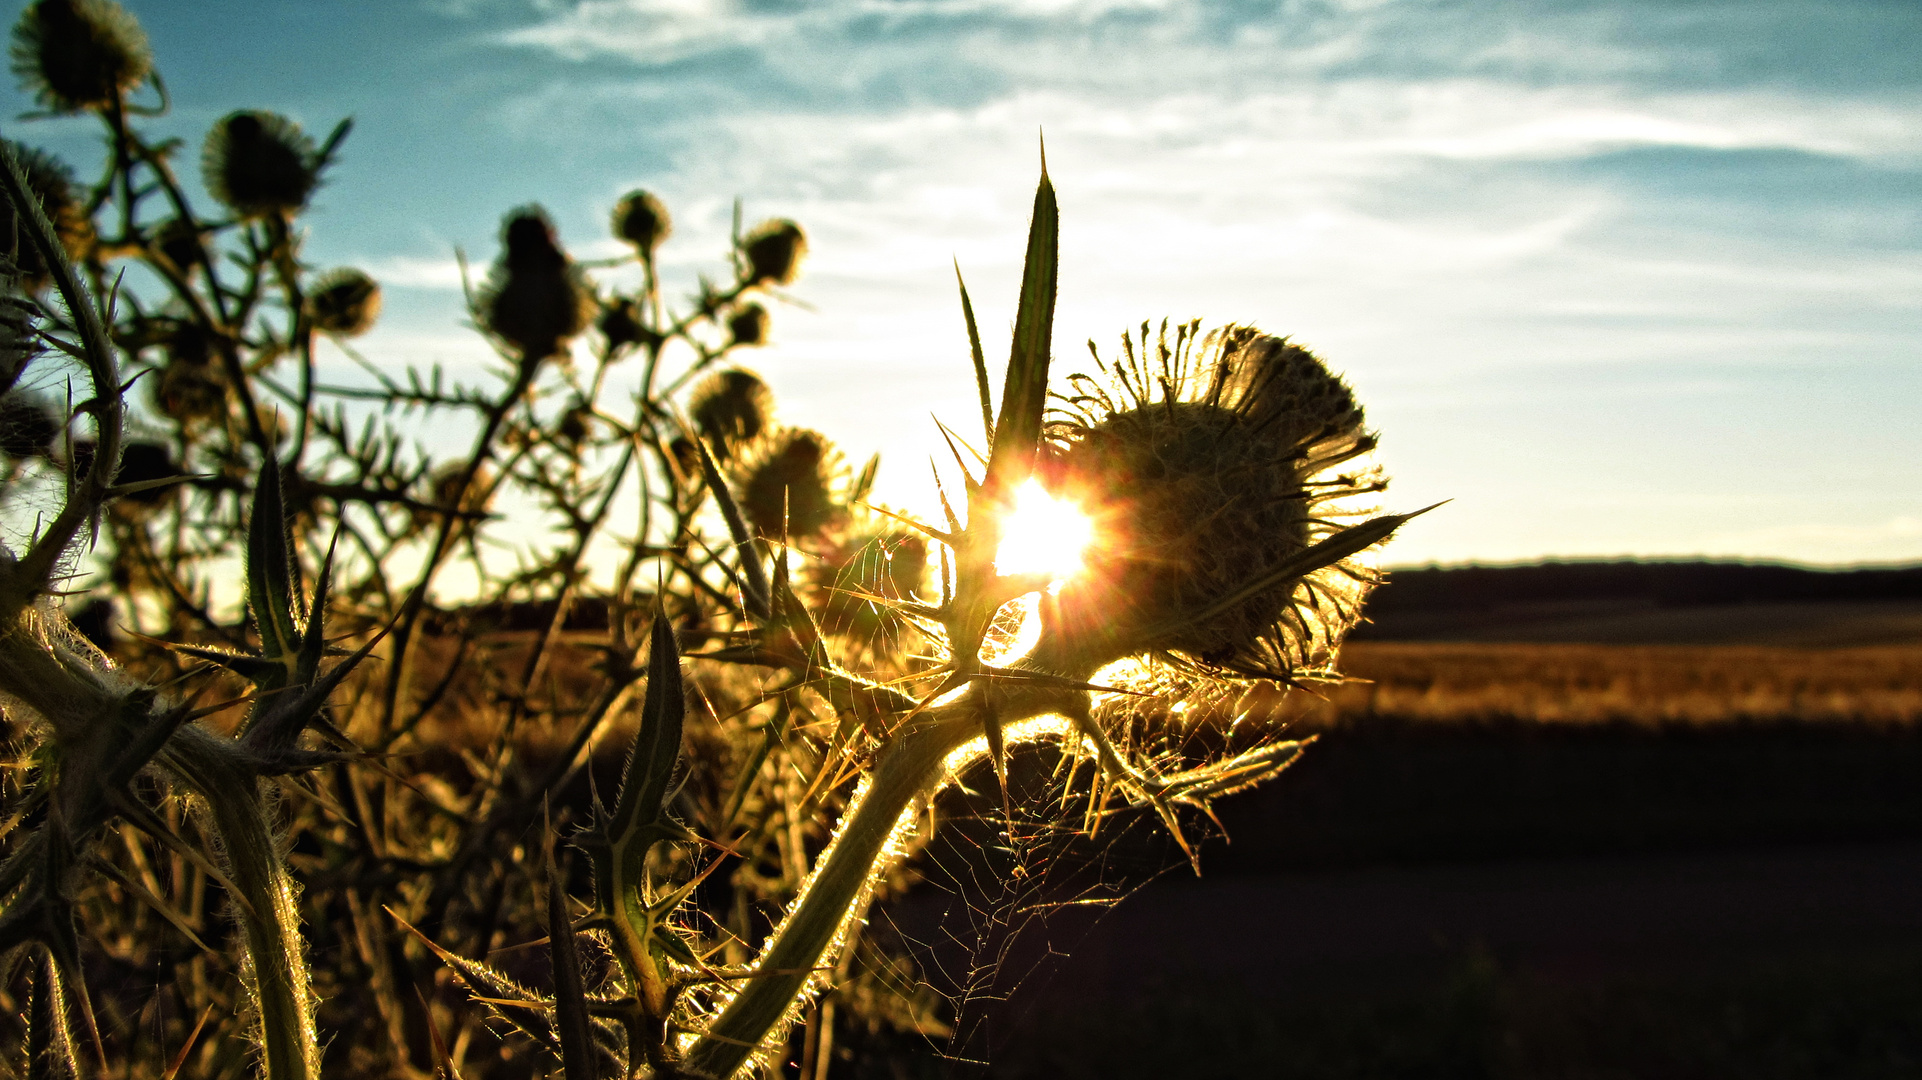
left=1042, top=315, right=1386, bottom=680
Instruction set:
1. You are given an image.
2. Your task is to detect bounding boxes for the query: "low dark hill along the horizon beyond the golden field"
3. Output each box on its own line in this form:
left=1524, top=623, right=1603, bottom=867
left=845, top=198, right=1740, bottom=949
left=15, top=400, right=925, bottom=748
left=1353, top=561, right=1922, bottom=646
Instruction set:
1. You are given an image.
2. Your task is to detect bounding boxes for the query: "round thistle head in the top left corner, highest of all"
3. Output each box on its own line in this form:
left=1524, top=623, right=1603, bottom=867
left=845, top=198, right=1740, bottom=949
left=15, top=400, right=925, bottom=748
left=12, top=0, right=154, bottom=113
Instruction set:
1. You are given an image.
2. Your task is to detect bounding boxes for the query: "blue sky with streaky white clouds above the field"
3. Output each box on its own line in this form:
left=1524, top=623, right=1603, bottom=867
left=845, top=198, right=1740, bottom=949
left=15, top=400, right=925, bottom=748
left=0, top=0, right=1922, bottom=565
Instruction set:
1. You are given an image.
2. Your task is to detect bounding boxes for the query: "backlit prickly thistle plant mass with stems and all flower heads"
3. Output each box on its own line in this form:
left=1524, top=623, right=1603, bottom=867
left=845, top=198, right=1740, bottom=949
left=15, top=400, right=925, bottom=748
left=0, top=0, right=1409, bottom=1080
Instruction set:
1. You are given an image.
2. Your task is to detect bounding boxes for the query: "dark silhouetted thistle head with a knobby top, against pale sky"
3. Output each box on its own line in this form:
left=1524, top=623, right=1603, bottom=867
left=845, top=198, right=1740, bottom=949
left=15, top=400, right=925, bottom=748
left=479, top=206, right=594, bottom=361
